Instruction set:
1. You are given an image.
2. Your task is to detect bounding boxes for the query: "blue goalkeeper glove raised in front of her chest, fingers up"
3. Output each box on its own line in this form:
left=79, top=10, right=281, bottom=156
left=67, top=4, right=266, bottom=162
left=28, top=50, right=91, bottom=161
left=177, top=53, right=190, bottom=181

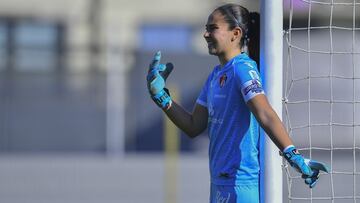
left=146, top=51, right=174, bottom=110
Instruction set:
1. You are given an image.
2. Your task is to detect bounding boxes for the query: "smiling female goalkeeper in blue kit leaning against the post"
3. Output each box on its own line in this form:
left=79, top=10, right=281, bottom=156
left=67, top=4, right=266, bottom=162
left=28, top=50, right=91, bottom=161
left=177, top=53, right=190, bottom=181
left=147, top=4, right=328, bottom=203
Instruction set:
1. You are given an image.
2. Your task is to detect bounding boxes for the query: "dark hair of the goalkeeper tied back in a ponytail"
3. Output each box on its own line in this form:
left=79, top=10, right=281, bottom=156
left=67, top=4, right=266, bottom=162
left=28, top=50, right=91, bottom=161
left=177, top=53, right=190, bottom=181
left=215, top=4, right=260, bottom=66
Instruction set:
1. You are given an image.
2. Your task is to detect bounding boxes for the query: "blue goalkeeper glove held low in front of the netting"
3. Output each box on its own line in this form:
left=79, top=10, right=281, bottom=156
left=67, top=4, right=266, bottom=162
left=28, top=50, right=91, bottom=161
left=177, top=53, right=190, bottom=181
left=282, top=145, right=330, bottom=188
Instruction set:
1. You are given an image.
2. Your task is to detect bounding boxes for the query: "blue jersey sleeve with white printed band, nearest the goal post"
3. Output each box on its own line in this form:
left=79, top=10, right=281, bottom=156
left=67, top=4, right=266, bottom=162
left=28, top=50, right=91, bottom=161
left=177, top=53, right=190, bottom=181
left=235, top=61, right=265, bottom=102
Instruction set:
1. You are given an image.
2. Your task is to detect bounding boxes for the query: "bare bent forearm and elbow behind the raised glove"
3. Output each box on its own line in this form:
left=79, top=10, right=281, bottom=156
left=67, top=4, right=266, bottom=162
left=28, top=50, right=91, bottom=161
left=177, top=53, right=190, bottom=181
left=164, top=101, right=208, bottom=138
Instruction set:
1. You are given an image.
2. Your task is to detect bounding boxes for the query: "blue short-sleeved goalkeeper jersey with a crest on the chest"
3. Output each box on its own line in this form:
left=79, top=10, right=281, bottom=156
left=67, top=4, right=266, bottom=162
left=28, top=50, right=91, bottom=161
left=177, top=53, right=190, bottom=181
left=196, top=53, right=264, bottom=185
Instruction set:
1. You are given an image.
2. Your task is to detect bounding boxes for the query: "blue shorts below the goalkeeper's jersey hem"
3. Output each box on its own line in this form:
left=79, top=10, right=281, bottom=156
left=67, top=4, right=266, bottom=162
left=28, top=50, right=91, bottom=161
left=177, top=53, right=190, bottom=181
left=210, top=184, right=260, bottom=203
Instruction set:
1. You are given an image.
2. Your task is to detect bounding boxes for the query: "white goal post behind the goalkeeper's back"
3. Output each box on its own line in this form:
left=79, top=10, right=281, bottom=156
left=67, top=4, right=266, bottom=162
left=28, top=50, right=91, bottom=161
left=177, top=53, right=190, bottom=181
left=260, top=0, right=283, bottom=203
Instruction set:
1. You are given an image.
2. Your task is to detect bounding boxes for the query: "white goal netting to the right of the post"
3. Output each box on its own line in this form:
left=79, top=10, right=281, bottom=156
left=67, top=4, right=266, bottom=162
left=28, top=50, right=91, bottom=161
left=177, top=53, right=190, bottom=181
left=284, top=0, right=360, bottom=203
